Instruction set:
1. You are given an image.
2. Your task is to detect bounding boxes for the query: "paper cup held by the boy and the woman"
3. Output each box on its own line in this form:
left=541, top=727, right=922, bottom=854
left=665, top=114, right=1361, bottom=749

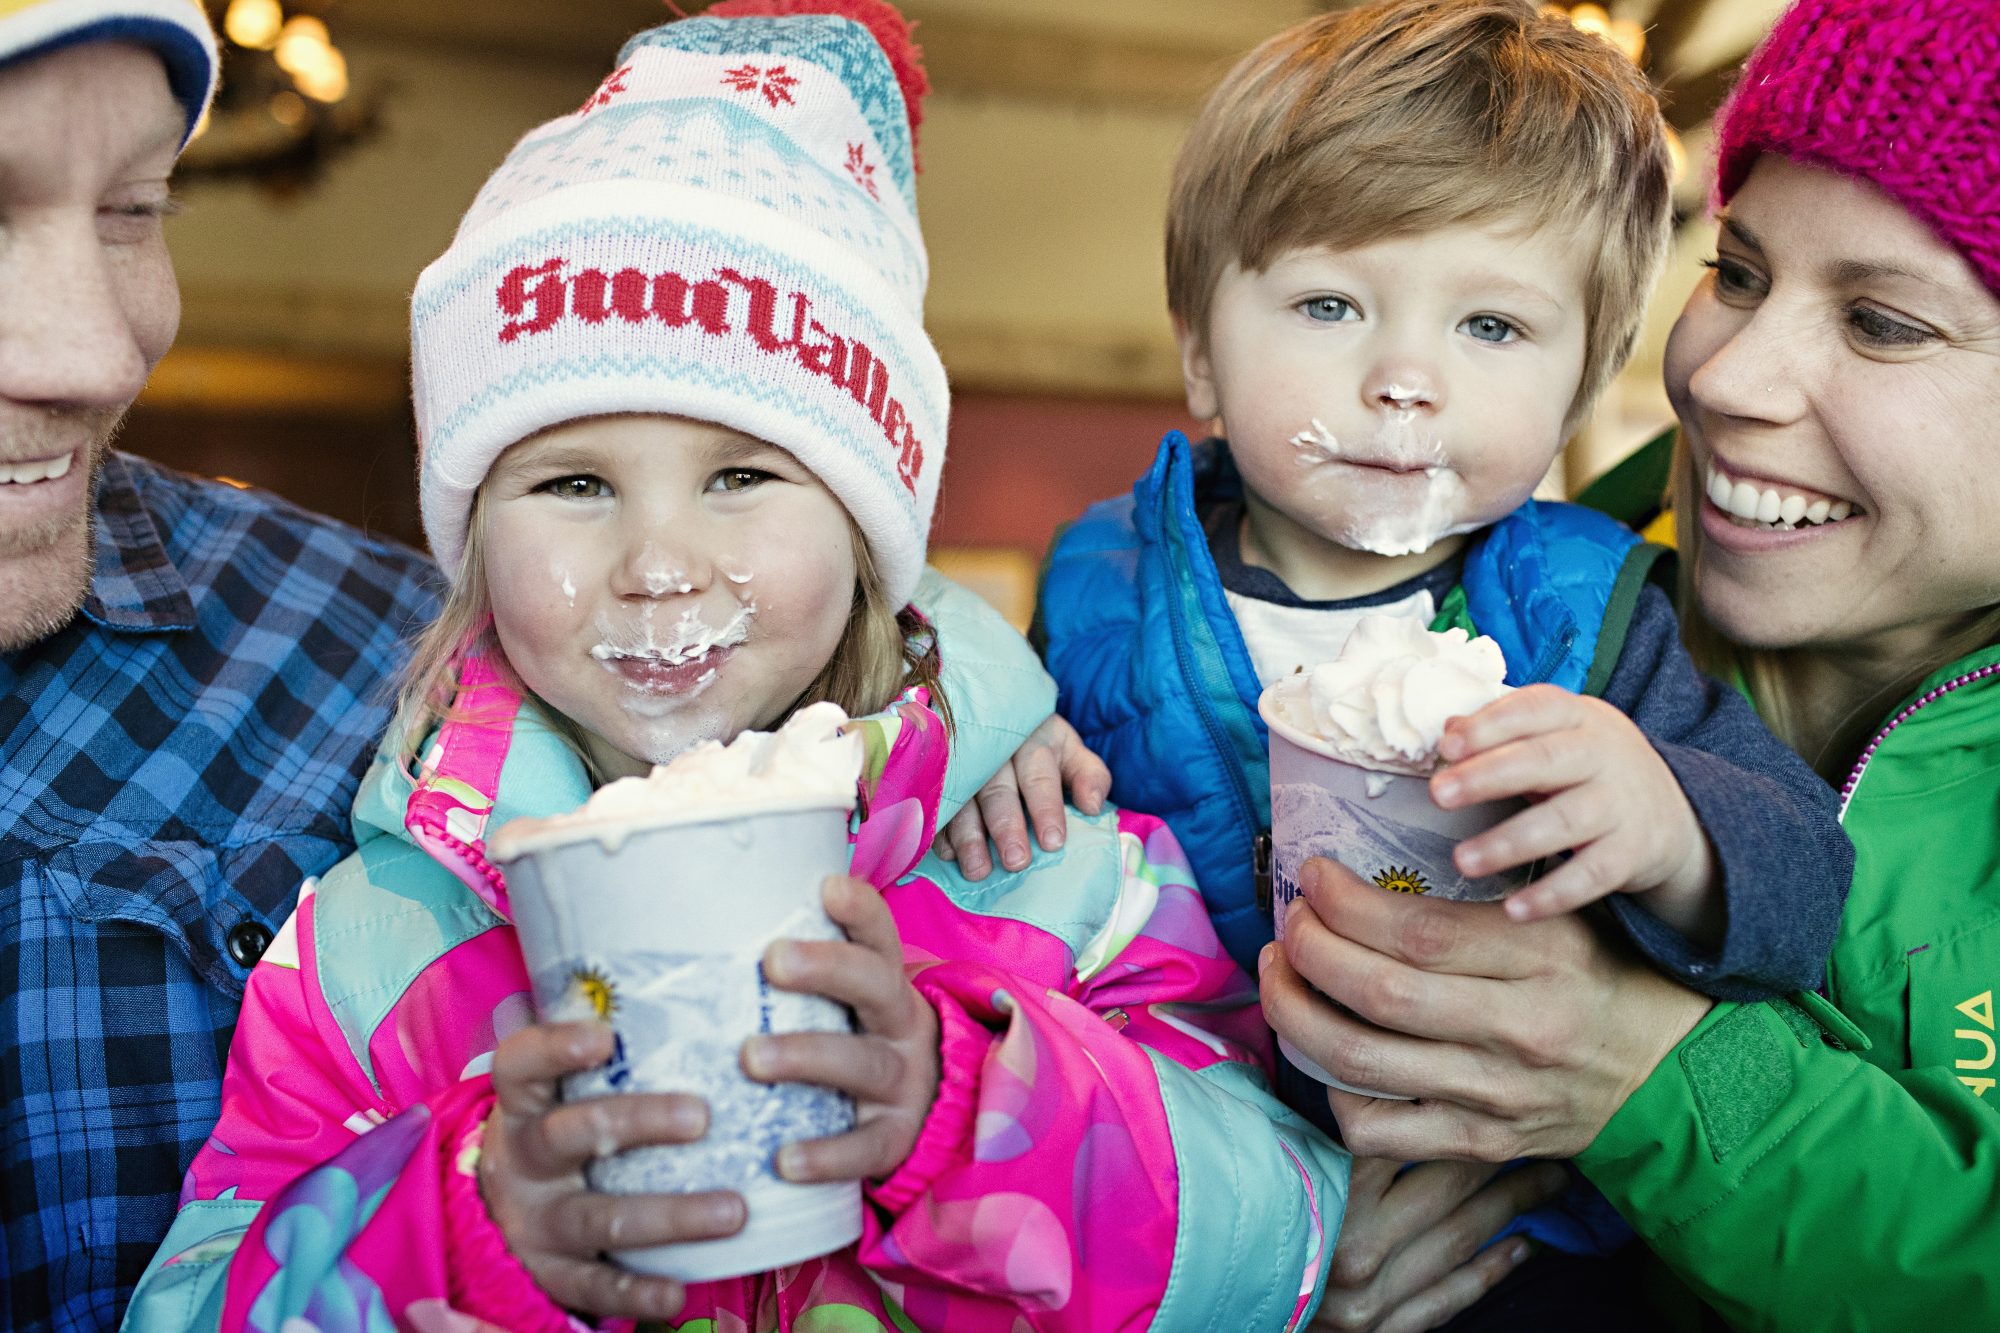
left=1258, top=677, right=1530, bottom=1101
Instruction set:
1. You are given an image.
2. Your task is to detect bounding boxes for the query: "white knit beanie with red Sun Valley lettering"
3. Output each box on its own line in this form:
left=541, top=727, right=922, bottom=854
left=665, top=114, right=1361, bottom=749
left=410, top=0, right=948, bottom=604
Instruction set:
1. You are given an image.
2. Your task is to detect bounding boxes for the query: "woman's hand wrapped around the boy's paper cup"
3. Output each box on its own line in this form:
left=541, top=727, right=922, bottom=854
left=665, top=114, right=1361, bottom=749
left=1258, top=859, right=1710, bottom=1161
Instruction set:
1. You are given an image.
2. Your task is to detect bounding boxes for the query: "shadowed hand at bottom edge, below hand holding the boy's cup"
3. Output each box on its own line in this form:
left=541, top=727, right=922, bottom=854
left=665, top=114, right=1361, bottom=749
left=1312, top=1157, right=1568, bottom=1333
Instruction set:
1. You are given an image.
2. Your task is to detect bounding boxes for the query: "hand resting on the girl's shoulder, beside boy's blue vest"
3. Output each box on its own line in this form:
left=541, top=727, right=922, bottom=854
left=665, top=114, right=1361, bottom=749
left=932, top=715, right=1112, bottom=879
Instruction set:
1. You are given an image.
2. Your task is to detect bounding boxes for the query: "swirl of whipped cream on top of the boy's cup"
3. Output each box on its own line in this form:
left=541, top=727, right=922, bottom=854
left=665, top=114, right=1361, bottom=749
left=1272, top=616, right=1512, bottom=773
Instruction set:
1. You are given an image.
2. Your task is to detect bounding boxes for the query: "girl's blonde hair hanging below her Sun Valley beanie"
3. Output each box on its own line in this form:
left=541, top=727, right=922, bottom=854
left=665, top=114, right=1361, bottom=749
left=390, top=490, right=952, bottom=785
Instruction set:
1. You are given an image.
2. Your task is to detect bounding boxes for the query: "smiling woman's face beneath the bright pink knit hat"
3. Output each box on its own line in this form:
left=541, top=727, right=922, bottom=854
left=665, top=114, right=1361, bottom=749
left=1666, top=154, right=2000, bottom=656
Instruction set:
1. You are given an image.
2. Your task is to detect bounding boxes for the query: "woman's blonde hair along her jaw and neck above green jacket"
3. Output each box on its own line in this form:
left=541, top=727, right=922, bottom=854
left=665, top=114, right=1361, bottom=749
left=1668, top=438, right=2000, bottom=768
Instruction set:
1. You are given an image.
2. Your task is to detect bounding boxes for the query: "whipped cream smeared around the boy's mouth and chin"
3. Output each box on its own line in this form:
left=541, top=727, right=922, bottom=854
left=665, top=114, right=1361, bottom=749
left=1290, top=418, right=1480, bottom=556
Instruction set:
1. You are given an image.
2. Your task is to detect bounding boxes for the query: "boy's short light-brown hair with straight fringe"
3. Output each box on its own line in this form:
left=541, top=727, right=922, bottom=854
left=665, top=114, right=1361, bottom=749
left=1166, top=0, right=1672, bottom=426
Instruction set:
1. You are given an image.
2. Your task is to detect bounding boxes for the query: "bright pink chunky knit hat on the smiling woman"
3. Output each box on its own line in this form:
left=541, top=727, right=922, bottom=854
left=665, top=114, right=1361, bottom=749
left=1716, top=0, right=2000, bottom=292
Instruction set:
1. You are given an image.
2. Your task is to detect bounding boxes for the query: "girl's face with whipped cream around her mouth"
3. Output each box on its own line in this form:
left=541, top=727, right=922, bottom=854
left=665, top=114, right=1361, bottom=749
left=482, top=416, right=856, bottom=777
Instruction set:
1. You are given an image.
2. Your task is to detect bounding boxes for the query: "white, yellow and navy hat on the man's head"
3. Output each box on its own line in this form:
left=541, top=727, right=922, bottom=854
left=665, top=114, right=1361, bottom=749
left=0, top=0, right=216, bottom=144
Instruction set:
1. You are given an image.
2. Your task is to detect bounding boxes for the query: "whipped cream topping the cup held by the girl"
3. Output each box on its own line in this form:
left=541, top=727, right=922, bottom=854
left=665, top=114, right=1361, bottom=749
left=492, top=703, right=864, bottom=861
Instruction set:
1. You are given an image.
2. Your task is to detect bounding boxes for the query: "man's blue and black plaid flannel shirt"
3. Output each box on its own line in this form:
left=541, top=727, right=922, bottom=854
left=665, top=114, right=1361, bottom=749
left=0, top=454, right=436, bottom=1331
